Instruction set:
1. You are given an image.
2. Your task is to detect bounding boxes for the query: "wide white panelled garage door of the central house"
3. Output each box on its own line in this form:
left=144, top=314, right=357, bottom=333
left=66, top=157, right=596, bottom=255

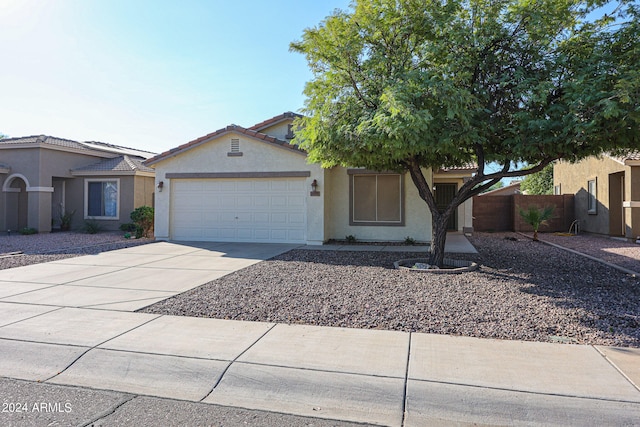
left=170, top=178, right=307, bottom=243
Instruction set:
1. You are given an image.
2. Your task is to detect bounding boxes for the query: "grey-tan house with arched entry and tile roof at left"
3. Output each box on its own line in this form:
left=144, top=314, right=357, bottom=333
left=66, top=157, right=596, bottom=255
left=0, top=135, right=154, bottom=233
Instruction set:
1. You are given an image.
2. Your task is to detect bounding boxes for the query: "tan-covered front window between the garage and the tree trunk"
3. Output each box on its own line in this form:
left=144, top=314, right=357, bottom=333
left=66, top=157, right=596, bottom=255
left=349, top=173, right=404, bottom=225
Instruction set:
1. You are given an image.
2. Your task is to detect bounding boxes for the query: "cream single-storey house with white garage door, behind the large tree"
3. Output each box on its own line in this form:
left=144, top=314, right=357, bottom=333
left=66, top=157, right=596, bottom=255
left=145, top=112, right=475, bottom=244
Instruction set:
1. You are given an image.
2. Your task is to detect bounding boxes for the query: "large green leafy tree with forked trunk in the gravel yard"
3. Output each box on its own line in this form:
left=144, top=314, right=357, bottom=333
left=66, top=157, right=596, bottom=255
left=290, top=0, right=640, bottom=265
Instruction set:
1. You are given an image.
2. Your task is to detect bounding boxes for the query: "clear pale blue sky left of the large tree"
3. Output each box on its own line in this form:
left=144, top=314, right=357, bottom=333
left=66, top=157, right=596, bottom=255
left=0, top=0, right=349, bottom=152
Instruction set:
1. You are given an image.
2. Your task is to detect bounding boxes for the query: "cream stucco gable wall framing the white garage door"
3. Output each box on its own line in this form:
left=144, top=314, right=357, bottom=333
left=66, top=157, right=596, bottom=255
left=153, top=130, right=325, bottom=244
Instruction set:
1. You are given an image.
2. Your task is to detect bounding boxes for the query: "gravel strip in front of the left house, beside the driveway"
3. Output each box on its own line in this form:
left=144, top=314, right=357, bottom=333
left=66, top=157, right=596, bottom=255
left=0, top=231, right=153, bottom=270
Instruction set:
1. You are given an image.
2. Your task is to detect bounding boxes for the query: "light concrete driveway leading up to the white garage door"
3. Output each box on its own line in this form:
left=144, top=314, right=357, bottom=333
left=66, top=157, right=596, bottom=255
left=0, top=242, right=299, bottom=311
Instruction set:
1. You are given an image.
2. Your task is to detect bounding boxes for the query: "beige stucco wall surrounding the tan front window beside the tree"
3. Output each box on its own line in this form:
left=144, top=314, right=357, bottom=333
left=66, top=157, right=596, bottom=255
left=325, top=167, right=431, bottom=242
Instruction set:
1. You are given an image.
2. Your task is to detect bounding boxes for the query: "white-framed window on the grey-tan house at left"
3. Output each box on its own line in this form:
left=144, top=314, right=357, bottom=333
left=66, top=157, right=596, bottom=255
left=84, top=179, right=120, bottom=220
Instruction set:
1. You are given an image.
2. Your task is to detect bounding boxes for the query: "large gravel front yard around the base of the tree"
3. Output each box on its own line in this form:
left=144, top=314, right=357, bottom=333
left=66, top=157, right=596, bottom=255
left=141, top=233, right=640, bottom=347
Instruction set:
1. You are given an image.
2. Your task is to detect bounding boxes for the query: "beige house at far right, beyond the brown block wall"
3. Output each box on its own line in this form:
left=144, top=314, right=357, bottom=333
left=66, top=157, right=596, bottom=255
left=553, top=152, right=640, bottom=239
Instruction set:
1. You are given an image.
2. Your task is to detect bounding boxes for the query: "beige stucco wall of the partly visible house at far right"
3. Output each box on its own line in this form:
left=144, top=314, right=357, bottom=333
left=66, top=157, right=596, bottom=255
left=553, top=156, right=630, bottom=234
